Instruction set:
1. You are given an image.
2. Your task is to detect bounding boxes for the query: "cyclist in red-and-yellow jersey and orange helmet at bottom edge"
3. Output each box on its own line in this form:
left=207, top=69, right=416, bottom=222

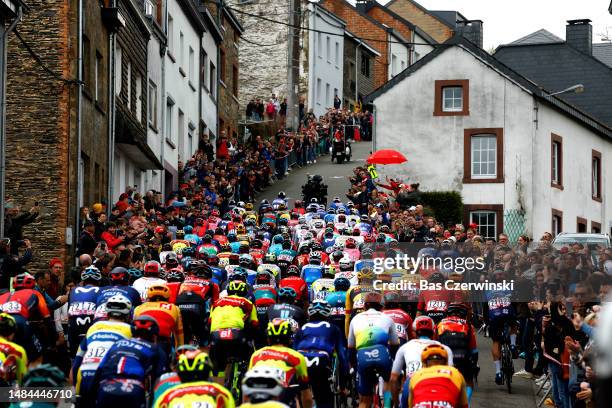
left=408, top=344, right=468, bottom=408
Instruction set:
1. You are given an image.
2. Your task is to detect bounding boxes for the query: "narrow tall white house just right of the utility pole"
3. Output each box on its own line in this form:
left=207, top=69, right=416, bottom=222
left=308, top=3, right=346, bottom=117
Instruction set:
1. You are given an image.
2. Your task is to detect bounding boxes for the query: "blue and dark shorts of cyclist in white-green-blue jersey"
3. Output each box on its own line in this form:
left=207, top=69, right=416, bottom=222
left=357, top=345, right=393, bottom=396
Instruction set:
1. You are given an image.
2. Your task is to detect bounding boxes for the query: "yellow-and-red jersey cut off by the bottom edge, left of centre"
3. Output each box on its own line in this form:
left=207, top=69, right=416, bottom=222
left=153, top=381, right=236, bottom=408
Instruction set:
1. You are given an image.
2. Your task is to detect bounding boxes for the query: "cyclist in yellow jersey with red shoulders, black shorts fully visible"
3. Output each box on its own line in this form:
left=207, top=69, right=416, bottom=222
left=209, top=280, right=259, bottom=378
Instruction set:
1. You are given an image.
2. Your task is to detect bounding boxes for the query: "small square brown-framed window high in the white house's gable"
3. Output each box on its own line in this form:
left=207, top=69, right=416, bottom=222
left=433, top=79, right=470, bottom=116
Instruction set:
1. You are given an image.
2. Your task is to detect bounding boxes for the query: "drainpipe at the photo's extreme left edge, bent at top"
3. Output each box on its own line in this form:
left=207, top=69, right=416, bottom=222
left=0, top=6, right=23, bottom=237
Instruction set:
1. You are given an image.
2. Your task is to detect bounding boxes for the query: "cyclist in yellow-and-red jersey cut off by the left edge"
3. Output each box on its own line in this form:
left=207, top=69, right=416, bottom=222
left=0, top=313, right=28, bottom=386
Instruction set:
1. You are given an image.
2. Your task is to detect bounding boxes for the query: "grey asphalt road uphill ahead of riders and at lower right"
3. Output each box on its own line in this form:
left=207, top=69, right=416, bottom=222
left=258, top=142, right=536, bottom=408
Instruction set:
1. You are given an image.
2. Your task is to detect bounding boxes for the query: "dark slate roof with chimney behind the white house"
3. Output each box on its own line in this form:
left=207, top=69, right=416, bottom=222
left=494, top=37, right=612, bottom=126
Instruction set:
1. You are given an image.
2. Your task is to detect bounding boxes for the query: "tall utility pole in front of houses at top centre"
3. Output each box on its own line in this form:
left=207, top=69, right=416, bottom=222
left=286, top=0, right=301, bottom=132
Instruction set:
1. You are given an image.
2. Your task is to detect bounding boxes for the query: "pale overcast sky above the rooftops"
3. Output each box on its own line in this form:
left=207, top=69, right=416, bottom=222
left=381, top=0, right=612, bottom=50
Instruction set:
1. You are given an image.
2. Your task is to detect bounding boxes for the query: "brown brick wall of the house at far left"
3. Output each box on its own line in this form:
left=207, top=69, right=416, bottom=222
left=6, top=0, right=74, bottom=272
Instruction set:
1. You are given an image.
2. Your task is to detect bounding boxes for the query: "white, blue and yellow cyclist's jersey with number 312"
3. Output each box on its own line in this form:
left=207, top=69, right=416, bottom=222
left=74, top=321, right=132, bottom=392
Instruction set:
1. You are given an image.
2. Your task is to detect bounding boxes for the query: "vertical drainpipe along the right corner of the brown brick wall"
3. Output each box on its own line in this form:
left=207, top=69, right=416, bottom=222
left=73, top=0, right=83, bottom=244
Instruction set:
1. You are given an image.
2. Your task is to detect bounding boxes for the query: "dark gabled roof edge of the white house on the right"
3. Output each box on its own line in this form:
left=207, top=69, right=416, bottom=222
left=365, top=34, right=612, bottom=140
